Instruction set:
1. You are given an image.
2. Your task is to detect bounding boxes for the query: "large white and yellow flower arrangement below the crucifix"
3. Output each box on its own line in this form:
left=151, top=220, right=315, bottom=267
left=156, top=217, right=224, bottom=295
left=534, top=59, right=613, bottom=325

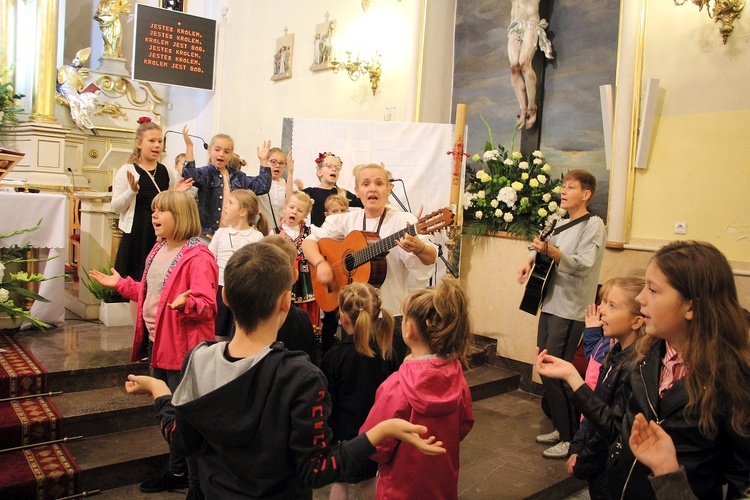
left=462, top=118, right=565, bottom=240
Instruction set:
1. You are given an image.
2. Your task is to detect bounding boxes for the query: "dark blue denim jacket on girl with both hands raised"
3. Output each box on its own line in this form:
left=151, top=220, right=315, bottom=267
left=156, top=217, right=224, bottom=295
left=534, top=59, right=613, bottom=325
left=182, top=160, right=271, bottom=234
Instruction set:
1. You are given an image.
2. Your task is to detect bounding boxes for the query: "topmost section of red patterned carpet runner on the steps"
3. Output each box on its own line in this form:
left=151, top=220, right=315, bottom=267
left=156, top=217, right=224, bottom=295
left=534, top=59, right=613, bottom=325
left=0, top=334, right=47, bottom=398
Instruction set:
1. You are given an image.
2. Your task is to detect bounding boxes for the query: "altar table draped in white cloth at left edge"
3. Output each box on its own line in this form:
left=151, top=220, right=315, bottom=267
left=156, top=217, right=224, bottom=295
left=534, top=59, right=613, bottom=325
left=0, top=191, right=68, bottom=327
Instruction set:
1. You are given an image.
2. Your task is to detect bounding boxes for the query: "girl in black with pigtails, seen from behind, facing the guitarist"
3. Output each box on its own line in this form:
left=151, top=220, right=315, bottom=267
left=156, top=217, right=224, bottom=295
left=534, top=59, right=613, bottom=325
left=320, top=283, right=401, bottom=500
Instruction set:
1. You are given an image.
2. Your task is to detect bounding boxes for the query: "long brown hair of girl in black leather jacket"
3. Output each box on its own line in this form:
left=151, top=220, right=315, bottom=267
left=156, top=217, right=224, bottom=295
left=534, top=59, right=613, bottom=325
left=638, top=241, right=750, bottom=437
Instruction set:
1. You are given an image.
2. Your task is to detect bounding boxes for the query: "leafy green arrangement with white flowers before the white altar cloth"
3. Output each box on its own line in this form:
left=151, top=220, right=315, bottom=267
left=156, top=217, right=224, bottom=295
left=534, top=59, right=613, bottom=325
left=0, top=219, right=62, bottom=330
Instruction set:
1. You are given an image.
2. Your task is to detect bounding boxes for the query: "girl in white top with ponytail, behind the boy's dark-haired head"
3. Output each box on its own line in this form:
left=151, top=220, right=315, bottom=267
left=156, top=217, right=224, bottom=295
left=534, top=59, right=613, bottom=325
left=208, top=189, right=268, bottom=340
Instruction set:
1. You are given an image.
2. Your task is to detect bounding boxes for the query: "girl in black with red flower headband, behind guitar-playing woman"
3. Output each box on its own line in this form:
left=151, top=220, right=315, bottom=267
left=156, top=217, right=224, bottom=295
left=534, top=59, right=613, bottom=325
left=289, top=152, right=363, bottom=354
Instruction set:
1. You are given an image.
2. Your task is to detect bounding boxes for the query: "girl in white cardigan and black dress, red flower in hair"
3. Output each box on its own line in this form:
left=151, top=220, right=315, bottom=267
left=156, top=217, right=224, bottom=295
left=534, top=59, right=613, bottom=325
left=110, top=116, right=193, bottom=281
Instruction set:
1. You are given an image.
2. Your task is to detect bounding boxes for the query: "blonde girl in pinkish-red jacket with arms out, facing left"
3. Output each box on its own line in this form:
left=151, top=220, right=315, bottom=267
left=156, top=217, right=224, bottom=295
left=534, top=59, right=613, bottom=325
left=89, top=190, right=218, bottom=493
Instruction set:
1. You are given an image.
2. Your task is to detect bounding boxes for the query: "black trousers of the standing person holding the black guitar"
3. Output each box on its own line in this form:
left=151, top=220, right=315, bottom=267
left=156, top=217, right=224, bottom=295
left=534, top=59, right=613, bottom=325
left=536, top=313, right=584, bottom=441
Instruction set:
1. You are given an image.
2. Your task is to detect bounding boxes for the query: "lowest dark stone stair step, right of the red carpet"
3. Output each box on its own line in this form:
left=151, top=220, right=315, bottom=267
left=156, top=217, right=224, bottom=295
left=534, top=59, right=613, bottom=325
left=68, top=426, right=169, bottom=491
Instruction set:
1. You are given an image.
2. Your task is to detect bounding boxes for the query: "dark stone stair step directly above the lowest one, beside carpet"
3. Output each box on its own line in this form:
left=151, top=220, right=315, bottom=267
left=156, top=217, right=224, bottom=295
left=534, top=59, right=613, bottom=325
left=53, top=381, right=157, bottom=437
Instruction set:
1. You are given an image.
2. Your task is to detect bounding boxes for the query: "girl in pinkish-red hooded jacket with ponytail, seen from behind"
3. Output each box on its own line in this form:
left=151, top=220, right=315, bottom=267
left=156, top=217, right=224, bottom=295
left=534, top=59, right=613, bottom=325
left=361, top=279, right=474, bottom=499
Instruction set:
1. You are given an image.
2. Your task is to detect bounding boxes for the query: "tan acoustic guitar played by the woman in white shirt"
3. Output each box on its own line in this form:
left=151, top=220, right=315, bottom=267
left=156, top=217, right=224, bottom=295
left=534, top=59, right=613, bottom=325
left=311, top=208, right=453, bottom=312
